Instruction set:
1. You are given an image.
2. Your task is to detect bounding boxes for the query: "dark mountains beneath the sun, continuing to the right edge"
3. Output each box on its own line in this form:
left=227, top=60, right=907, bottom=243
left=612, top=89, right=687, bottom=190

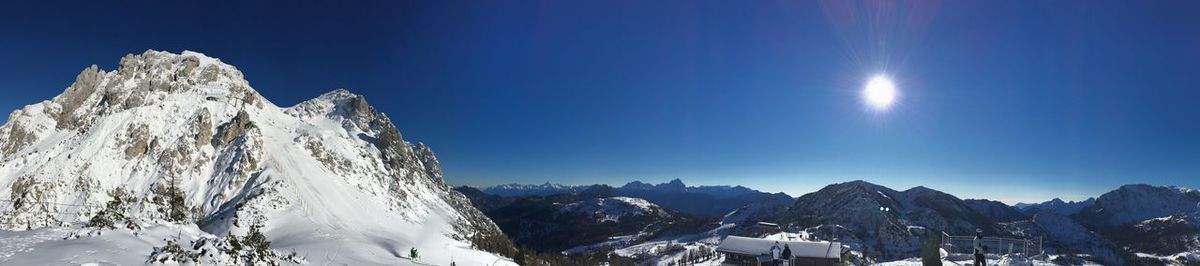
left=781, top=181, right=1200, bottom=265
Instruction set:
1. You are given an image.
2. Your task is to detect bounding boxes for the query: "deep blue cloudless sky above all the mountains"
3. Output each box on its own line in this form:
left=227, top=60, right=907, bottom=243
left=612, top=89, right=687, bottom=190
left=0, top=1, right=1200, bottom=202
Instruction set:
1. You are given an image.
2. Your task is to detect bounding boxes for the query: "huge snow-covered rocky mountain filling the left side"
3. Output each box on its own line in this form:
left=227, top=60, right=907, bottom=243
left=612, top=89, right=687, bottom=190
left=0, top=50, right=506, bottom=265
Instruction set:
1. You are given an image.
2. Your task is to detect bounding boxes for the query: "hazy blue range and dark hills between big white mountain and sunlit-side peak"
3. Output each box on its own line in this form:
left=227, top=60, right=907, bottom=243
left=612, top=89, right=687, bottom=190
left=455, top=179, right=794, bottom=253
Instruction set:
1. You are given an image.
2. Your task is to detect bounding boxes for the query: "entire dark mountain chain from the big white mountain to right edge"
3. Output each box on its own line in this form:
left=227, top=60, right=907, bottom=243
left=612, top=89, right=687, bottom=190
left=458, top=180, right=1200, bottom=265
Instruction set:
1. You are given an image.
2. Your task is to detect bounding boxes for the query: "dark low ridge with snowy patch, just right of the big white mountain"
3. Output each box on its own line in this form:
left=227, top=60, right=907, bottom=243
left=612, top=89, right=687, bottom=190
left=455, top=186, right=707, bottom=253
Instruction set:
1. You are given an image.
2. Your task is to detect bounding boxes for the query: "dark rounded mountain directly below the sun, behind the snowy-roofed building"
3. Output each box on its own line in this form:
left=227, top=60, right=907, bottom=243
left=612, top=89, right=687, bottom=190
left=780, top=181, right=1000, bottom=258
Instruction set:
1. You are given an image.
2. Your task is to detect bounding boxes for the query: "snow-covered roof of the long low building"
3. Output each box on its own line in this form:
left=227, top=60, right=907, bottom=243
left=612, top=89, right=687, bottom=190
left=716, top=236, right=841, bottom=259
